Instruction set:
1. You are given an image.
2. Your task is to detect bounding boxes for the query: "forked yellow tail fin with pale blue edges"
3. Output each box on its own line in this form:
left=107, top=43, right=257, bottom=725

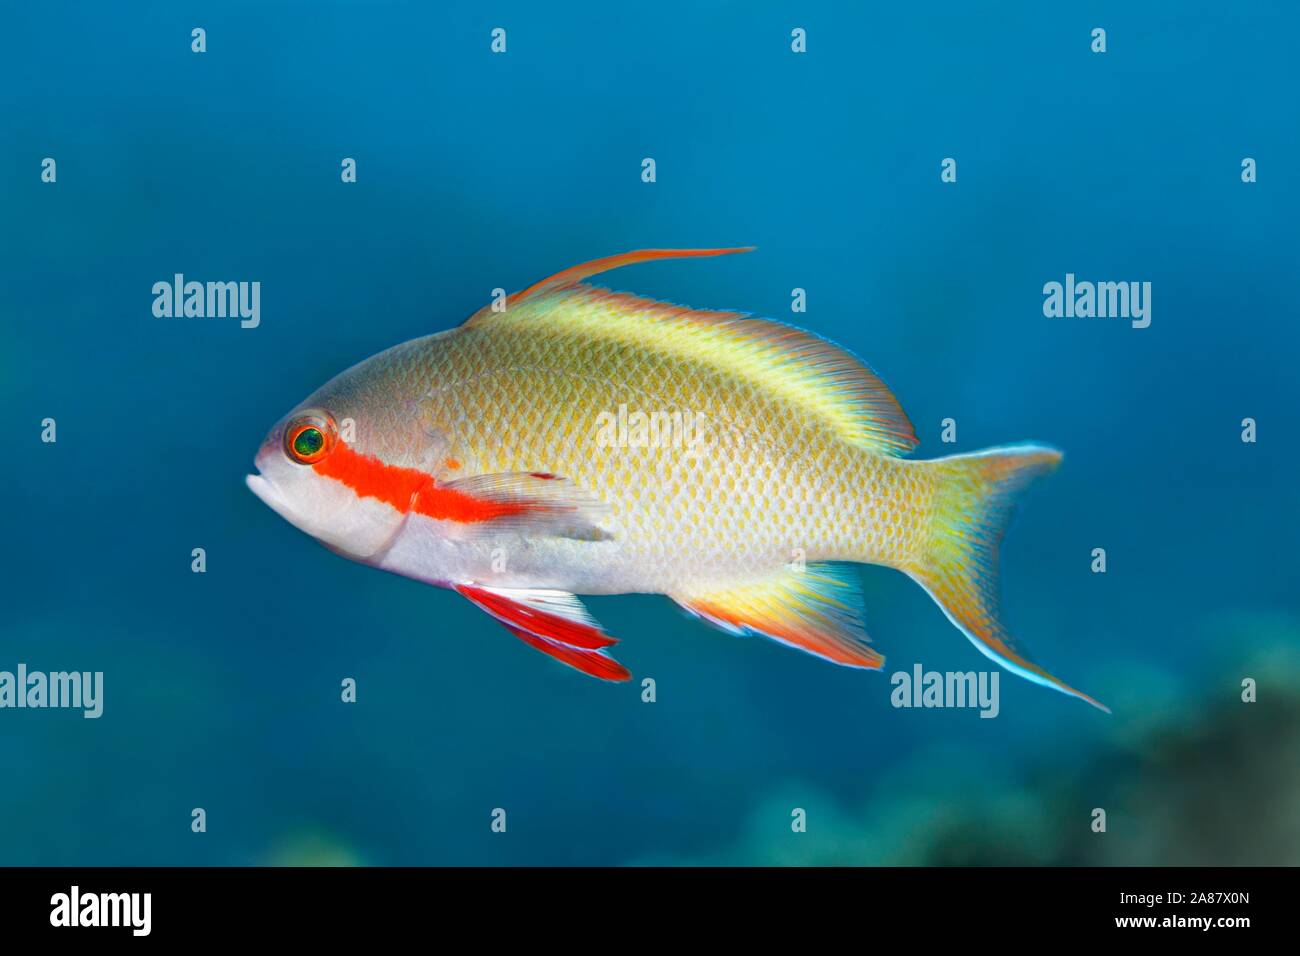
left=904, top=445, right=1110, bottom=713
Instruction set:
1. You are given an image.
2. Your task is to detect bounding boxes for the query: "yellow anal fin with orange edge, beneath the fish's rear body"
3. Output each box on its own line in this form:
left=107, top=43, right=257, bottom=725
left=670, top=563, right=885, bottom=670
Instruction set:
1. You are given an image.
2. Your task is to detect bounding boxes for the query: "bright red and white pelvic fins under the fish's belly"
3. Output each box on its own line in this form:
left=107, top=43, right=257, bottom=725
left=456, top=584, right=632, bottom=680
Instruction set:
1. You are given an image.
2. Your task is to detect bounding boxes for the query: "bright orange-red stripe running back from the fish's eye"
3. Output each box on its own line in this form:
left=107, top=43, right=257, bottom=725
left=312, top=442, right=532, bottom=523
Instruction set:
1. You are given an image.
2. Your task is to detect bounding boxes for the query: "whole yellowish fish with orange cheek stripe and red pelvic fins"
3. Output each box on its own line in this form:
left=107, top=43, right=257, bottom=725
left=246, top=247, right=1106, bottom=710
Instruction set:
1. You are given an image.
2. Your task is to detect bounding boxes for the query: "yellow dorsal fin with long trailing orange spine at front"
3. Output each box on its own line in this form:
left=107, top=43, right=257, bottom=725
left=465, top=248, right=918, bottom=455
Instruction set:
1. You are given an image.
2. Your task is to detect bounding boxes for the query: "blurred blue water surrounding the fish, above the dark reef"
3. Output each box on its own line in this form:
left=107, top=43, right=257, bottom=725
left=0, top=3, right=1300, bottom=864
